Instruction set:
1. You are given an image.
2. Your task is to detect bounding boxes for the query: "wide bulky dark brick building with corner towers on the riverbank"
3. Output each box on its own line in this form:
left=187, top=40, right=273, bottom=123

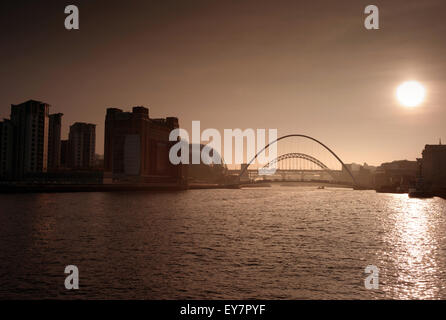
left=104, top=106, right=181, bottom=183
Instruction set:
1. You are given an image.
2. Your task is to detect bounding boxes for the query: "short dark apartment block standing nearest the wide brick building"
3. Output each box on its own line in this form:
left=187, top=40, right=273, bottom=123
left=67, top=122, right=96, bottom=169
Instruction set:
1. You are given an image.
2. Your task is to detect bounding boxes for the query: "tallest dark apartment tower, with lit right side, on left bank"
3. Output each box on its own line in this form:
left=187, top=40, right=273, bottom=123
left=11, top=100, right=50, bottom=178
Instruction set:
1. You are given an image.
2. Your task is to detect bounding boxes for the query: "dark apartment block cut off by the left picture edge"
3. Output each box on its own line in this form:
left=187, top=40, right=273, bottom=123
left=0, top=119, right=14, bottom=179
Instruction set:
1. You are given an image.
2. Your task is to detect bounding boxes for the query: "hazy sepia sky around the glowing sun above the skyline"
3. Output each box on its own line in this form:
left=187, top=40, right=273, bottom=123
left=0, top=0, right=446, bottom=165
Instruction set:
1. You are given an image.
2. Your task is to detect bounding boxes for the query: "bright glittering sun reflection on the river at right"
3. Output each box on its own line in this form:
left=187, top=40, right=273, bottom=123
left=384, top=195, right=440, bottom=299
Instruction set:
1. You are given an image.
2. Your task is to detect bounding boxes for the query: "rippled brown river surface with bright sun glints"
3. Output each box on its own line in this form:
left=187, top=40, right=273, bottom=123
left=0, top=186, right=446, bottom=299
